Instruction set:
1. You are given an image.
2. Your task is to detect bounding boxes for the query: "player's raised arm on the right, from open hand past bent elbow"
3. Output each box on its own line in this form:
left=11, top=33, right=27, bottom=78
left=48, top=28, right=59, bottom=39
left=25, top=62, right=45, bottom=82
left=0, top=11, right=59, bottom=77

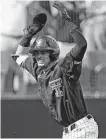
left=53, top=1, right=87, bottom=61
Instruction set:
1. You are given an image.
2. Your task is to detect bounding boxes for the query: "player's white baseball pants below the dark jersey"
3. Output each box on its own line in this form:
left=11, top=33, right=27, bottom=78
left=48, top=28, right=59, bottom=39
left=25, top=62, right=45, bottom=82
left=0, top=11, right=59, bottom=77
left=62, top=114, right=98, bottom=139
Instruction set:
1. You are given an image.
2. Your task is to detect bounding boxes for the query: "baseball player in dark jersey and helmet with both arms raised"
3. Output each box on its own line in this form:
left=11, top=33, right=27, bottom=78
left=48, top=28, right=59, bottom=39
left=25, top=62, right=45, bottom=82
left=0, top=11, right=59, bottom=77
left=12, top=2, right=98, bottom=139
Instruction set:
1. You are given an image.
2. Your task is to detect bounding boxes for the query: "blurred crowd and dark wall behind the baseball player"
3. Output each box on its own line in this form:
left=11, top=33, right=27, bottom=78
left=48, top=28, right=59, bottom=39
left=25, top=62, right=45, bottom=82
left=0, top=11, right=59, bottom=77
left=0, top=0, right=106, bottom=138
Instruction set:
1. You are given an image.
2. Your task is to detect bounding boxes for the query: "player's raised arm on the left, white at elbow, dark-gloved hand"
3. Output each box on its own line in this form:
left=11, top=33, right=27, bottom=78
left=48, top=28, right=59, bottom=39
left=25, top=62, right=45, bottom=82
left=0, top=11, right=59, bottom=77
left=11, top=13, right=47, bottom=65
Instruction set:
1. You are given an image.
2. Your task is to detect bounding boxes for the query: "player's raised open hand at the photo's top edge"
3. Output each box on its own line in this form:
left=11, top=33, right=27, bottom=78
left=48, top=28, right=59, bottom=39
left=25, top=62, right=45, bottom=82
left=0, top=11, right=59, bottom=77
left=53, top=1, right=71, bottom=19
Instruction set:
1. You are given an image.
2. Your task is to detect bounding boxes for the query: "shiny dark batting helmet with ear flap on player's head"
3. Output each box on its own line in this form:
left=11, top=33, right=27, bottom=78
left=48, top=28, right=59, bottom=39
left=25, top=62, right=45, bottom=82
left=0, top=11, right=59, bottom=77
left=29, top=35, right=60, bottom=61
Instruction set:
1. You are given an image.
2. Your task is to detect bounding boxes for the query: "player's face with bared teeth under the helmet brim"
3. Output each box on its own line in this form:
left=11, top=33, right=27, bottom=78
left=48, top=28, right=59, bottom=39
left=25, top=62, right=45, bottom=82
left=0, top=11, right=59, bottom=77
left=34, top=51, right=51, bottom=67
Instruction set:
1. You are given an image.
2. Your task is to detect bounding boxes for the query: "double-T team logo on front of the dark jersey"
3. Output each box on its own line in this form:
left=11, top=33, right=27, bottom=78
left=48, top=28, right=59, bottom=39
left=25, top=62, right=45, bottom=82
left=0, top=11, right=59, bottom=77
left=49, top=78, right=63, bottom=97
